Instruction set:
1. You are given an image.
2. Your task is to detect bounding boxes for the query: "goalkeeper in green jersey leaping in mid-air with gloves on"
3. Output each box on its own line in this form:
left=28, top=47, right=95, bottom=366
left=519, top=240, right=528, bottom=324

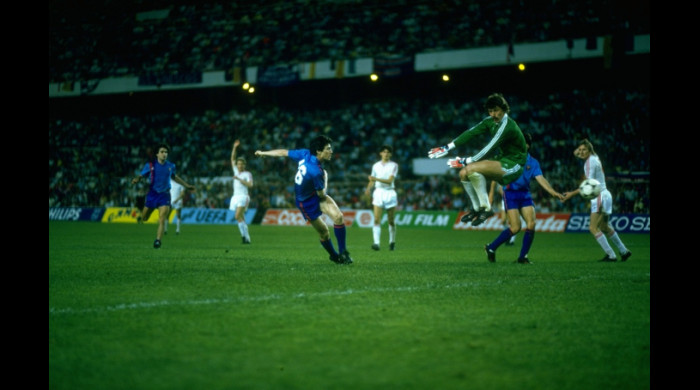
left=428, top=93, right=527, bottom=226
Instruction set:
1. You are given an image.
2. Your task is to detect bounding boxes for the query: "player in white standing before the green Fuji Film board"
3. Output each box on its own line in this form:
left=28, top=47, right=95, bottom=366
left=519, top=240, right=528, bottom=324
left=365, top=145, right=399, bottom=251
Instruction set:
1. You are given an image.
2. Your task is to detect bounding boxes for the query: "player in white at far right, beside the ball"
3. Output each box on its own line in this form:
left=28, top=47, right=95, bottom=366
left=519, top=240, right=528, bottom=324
left=564, top=139, right=632, bottom=262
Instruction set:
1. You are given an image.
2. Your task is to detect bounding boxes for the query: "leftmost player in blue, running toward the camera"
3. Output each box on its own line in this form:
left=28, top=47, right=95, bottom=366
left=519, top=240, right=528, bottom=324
left=131, top=144, right=195, bottom=248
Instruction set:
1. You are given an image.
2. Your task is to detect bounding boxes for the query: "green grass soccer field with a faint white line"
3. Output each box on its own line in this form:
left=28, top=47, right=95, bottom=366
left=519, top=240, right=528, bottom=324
left=49, top=221, right=651, bottom=390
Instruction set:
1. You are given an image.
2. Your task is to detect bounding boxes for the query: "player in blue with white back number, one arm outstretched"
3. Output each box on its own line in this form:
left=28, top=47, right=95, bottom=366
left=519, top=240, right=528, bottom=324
left=255, top=135, right=352, bottom=264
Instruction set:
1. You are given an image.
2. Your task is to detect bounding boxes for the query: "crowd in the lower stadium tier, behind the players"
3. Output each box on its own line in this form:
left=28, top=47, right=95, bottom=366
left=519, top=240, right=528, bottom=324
left=49, top=85, right=651, bottom=213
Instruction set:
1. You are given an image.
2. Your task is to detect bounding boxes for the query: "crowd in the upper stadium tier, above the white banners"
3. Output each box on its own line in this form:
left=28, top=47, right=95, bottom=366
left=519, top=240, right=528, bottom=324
left=49, top=0, right=650, bottom=83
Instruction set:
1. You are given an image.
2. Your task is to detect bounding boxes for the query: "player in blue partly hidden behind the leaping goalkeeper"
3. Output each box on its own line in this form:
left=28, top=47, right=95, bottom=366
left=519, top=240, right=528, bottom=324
left=484, top=133, right=564, bottom=264
